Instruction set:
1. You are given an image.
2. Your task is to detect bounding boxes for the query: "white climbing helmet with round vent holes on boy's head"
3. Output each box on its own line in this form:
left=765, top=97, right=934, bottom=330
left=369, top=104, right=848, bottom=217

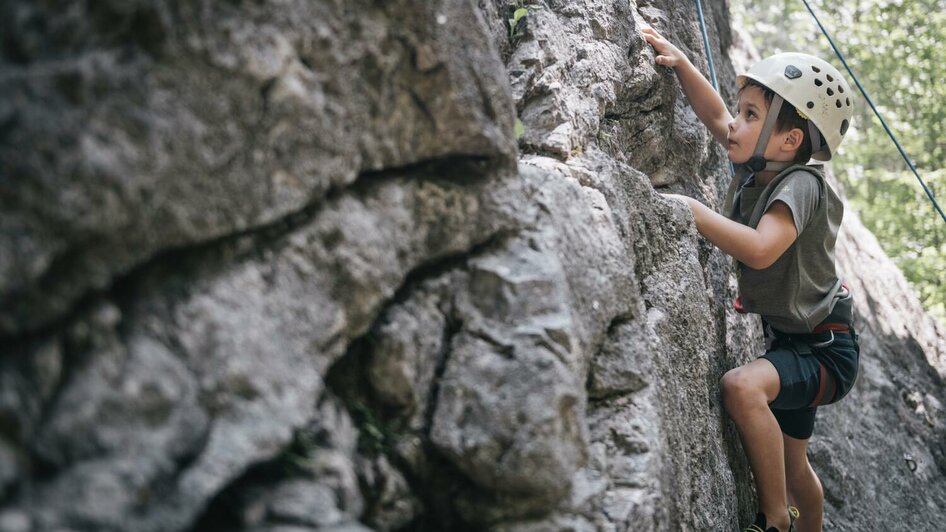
left=736, top=53, right=854, bottom=161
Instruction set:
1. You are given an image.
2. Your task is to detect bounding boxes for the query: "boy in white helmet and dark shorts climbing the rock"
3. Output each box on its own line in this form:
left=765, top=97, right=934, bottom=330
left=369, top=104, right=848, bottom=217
left=642, top=28, right=859, bottom=532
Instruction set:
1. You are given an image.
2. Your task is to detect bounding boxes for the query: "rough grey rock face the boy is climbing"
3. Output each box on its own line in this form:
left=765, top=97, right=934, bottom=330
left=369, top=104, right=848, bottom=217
left=0, top=0, right=946, bottom=532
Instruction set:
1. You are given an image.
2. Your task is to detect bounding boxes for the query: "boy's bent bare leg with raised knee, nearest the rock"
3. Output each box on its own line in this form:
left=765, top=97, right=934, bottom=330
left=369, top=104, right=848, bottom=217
left=720, top=358, right=790, bottom=530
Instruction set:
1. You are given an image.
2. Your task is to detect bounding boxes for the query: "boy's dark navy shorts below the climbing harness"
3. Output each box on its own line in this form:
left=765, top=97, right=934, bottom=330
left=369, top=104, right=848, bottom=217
left=761, top=329, right=860, bottom=440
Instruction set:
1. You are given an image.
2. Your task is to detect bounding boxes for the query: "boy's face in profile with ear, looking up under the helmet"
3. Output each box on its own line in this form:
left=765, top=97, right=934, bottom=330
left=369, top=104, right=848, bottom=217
left=728, top=85, right=801, bottom=164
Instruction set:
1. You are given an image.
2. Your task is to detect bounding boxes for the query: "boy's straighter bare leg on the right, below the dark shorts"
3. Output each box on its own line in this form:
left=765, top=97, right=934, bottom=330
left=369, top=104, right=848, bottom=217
left=782, top=434, right=824, bottom=532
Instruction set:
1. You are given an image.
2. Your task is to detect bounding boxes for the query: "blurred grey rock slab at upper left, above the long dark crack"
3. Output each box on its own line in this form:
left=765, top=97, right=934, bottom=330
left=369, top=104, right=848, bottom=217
left=0, top=0, right=514, bottom=335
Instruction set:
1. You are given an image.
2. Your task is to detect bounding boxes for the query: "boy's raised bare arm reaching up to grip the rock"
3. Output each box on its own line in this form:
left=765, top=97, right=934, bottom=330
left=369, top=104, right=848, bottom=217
left=641, top=27, right=732, bottom=146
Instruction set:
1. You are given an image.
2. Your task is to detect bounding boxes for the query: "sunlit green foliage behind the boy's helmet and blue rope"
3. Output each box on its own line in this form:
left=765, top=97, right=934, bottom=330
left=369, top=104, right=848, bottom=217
left=731, top=0, right=946, bottom=323
